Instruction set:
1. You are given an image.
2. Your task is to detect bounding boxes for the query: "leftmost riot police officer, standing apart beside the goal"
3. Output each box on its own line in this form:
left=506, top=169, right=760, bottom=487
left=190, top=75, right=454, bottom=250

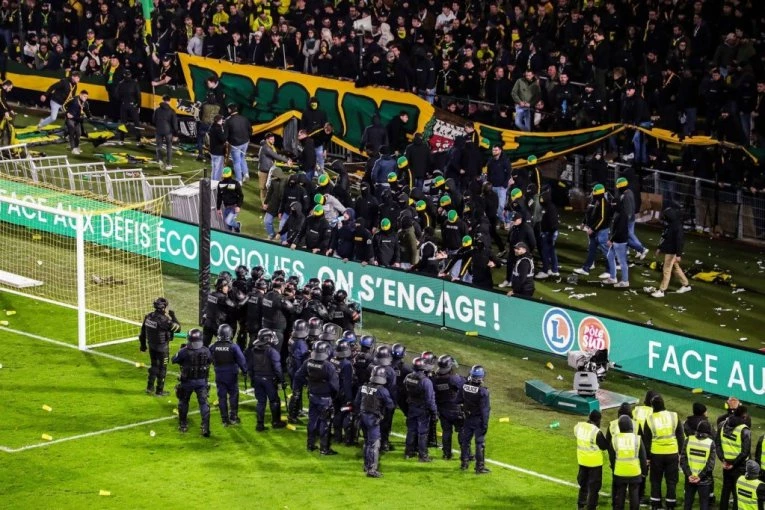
left=138, top=297, right=181, bottom=396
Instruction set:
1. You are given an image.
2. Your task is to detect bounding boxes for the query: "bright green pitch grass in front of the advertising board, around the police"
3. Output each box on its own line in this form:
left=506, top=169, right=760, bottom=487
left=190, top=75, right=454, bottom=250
left=0, top=284, right=765, bottom=510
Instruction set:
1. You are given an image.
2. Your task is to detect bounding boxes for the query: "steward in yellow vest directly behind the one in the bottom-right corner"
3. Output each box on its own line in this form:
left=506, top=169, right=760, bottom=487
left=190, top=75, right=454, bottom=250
left=715, top=402, right=752, bottom=510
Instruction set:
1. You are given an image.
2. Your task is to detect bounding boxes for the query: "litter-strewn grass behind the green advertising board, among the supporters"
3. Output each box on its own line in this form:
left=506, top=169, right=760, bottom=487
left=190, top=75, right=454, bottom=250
left=8, top=117, right=765, bottom=349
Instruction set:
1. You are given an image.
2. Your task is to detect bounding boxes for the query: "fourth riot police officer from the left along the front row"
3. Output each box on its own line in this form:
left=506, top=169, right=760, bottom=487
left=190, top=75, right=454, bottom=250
left=246, top=328, right=286, bottom=432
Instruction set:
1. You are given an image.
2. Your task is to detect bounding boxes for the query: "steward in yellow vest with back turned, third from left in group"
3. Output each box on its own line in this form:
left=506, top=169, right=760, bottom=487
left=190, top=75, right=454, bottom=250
left=643, top=395, right=685, bottom=510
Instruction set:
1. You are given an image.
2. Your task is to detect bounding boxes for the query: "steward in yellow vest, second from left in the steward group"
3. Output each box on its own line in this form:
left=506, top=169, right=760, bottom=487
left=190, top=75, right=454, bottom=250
left=608, top=416, right=648, bottom=510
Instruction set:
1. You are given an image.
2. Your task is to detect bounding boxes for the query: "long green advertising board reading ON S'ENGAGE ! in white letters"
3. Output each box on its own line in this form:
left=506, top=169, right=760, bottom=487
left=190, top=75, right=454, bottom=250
left=0, top=181, right=765, bottom=405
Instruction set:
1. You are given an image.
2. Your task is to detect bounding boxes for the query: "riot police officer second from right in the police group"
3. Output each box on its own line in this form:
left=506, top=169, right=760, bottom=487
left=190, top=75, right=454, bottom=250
left=433, top=354, right=465, bottom=460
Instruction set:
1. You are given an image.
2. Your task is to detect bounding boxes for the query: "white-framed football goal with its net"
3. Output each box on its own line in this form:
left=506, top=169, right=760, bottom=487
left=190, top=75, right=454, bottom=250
left=0, top=179, right=163, bottom=349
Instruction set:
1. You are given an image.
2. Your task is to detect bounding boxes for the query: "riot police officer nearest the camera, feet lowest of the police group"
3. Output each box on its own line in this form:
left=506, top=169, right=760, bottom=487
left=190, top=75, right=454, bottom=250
left=354, top=366, right=396, bottom=478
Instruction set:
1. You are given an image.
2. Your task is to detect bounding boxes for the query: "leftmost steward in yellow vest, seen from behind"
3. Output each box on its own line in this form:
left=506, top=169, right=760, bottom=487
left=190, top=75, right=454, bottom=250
left=574, top=410, right=608, bottom=510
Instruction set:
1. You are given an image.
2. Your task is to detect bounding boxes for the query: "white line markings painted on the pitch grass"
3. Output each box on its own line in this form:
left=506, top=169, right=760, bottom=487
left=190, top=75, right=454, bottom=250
left=0, top=326, right=610, bottom=497
